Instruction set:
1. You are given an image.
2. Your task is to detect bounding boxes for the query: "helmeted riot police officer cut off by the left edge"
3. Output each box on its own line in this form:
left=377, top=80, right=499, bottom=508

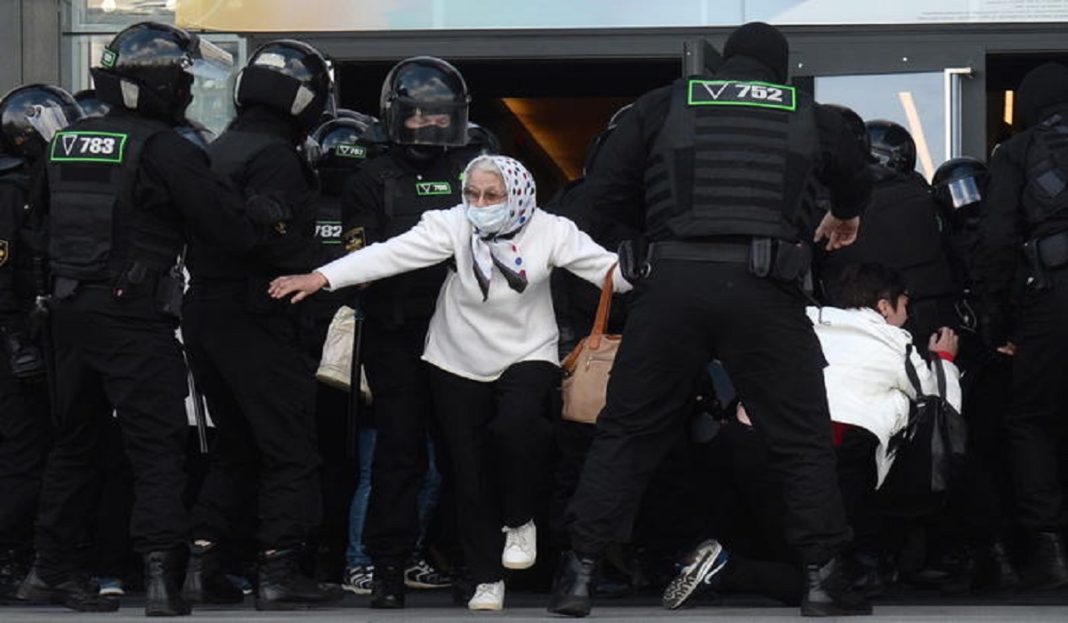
left=0, top=84, right=81, bottom=599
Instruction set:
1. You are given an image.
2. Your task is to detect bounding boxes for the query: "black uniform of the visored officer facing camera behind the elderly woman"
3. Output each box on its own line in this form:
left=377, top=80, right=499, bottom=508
left=342, top=146, right=478, bottom=567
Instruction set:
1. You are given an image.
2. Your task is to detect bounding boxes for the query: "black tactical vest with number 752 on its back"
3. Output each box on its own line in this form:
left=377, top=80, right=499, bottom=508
left=645, top=78, right=819, bottom=240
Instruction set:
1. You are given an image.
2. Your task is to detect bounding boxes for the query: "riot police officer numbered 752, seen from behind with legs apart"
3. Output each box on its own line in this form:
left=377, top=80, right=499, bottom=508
left=549, top=22, right=870, bottom=617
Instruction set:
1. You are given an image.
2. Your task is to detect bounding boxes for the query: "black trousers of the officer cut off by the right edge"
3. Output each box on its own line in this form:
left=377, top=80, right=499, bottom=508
left=1005, top=268, right=1068, bottom=531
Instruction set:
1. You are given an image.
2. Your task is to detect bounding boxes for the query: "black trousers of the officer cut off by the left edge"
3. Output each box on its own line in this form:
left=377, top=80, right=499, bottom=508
left=0, top=365, right=52, bottom=549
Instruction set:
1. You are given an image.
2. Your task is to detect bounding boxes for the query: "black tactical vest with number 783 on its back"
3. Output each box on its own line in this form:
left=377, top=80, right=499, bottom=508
left=47, top=115, right=184, bottom=282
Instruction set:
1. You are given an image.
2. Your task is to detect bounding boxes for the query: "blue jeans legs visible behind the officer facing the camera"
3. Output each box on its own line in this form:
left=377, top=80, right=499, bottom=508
left=345, top=429, right=441, bottom=567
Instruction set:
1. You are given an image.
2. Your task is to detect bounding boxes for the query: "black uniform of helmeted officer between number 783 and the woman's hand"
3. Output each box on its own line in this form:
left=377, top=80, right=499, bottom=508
left=183, top=107, right=321, bottom=549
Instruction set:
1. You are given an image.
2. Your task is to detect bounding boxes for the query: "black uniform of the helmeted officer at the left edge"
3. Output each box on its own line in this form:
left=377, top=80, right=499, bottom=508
left=0, top=155, right=51, bottom=581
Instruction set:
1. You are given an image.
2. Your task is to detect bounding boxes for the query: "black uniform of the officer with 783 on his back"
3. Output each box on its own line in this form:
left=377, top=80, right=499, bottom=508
left=33, top=110, right=256, bottom=580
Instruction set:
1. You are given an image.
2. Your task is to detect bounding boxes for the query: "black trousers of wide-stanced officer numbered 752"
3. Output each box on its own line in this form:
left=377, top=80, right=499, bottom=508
left=569, top=260, right=850, bottom=562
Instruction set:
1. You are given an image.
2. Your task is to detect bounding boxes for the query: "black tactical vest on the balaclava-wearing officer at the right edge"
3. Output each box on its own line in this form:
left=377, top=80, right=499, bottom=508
left=1022, top=114, right=1068, bottom=225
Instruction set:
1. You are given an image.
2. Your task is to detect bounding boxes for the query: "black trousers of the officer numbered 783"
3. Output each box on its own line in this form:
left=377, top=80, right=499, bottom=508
left=36, top=287, right=189, bottom=574
